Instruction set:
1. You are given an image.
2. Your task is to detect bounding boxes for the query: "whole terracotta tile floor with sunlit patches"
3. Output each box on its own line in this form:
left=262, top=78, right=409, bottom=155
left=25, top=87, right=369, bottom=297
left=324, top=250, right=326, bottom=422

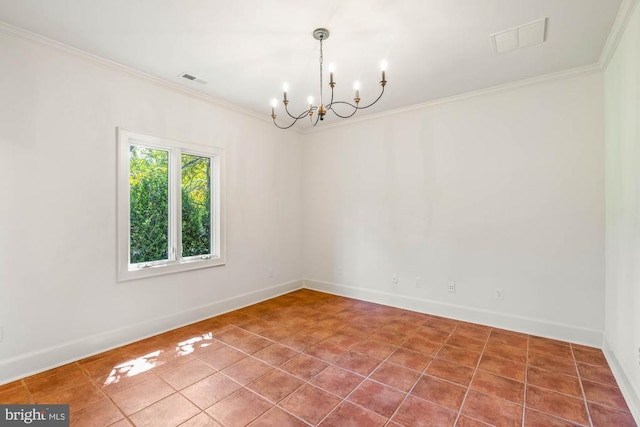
left=0, top=290, right=636, bottom=427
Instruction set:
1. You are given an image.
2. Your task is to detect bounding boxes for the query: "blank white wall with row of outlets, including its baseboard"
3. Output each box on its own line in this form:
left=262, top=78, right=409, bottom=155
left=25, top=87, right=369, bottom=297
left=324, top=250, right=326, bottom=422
left=303, top=72, right=604, bottom=346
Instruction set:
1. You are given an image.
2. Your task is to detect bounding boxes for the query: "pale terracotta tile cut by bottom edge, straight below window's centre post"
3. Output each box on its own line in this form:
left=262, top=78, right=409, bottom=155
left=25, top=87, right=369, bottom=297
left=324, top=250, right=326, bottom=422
left=129, top=393, right=200, bottom=427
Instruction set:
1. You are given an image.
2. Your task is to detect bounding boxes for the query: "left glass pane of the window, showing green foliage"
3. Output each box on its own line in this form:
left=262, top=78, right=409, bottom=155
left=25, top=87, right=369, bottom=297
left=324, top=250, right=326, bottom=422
left=129, top=145, right=169, bottom=264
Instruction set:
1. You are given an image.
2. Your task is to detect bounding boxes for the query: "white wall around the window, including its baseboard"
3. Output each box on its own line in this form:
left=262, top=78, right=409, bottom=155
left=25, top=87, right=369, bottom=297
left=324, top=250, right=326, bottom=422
left=0, top=31, right=302, bottom=383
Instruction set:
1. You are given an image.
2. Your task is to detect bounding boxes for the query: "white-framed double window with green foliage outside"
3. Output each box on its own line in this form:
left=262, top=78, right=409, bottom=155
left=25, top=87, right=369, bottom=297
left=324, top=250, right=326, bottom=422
left=118, top=129, right=225, bottom=280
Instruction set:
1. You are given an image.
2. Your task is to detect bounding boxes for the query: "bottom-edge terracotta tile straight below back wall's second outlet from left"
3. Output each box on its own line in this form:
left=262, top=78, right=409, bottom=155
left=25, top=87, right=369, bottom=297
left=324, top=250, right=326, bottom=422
left=392, top=395, right=456, bottom=427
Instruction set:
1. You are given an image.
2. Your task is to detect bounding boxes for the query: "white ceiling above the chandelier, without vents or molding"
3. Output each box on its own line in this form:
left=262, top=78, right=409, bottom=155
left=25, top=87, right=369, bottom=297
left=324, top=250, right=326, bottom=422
left=0, top=0, right=622, bottom=125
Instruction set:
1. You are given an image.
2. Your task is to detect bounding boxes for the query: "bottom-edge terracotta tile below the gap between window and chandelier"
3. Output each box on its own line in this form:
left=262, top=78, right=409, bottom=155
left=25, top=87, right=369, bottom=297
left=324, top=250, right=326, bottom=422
left=206, top=388, right=273, bottom=427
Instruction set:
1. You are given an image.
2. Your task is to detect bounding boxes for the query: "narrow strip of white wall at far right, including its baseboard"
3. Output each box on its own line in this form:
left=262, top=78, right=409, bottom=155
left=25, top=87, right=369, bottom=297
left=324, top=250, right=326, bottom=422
left=605, top=1, right=640, bottom=420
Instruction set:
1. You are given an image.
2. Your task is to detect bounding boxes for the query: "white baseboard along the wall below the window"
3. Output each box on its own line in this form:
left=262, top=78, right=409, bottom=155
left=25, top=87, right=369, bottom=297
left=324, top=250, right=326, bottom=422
left=0, top=280, right=303, bottom=385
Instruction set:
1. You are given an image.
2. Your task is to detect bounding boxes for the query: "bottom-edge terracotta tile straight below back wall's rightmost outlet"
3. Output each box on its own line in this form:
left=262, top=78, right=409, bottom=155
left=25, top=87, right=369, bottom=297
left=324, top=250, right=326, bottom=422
left=461, top=390, right=522, bottom=426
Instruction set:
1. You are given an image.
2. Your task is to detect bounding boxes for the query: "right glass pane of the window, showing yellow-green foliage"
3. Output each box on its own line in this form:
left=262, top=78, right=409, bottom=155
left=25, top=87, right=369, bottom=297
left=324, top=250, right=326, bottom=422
left=182, top=154, right=211, bottom=257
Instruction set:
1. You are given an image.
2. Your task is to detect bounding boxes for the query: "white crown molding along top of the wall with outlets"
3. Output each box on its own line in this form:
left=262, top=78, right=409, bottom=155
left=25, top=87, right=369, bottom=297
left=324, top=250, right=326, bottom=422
left=302, top=61, right=604, bottom=134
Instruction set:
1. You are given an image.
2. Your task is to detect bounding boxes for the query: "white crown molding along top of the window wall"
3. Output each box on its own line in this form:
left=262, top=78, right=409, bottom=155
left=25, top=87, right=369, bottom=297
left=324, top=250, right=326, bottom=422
left=0, top=21, right=282, bottom=128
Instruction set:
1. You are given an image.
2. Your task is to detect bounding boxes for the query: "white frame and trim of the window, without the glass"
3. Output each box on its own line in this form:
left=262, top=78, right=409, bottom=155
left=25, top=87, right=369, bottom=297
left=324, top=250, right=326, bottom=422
left=117, top=128, right=226, bottom=281
